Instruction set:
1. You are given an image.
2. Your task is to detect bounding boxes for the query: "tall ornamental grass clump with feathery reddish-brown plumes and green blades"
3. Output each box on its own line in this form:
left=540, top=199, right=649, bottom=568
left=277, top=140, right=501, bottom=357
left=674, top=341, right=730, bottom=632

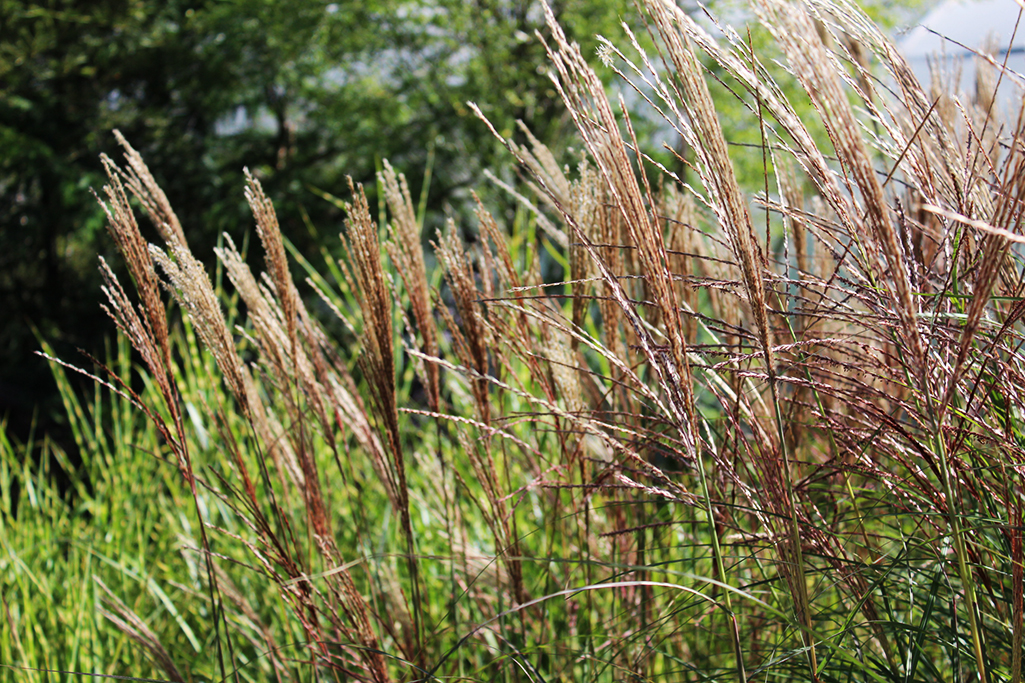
left=0, top=0, right=1025, bottom=683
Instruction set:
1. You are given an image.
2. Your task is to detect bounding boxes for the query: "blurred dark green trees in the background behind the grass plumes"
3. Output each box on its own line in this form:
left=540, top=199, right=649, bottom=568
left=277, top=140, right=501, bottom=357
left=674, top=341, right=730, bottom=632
left=0, top=0, right=634, bottom=445
